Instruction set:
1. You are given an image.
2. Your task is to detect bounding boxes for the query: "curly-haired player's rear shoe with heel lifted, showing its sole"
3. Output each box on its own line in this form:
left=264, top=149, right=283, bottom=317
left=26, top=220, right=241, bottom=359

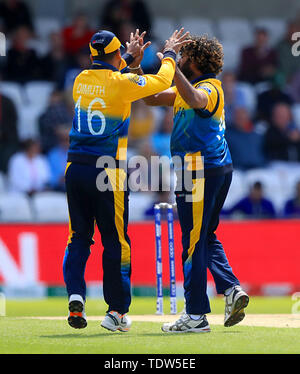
left=224, top=286, right=249, bottom=327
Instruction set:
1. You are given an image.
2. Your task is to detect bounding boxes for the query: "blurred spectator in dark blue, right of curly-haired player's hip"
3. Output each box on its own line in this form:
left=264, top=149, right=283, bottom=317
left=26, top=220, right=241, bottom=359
left=222, top=182, right=276, bottom=219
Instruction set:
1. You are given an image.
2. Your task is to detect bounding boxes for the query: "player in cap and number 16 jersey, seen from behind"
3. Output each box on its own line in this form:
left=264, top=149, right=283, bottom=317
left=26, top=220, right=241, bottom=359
left=63, top=29, right=191, bottom=331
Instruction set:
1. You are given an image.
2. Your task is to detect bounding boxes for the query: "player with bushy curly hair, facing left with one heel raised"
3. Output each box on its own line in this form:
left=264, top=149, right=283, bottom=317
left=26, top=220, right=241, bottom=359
left=144, top=36, right=249, bottom=333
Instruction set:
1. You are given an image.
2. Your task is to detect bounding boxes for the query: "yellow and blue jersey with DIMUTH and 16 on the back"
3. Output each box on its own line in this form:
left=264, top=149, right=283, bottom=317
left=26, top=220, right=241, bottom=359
left=68, top=52, right=176, bottom=162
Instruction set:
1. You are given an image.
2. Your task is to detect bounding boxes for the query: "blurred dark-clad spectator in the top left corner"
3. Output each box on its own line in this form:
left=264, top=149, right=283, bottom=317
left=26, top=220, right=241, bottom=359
left=0, top=0, right=33, bottom=36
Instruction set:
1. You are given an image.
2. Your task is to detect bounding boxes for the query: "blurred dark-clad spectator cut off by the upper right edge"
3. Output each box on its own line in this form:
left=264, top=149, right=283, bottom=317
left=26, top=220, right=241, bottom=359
left=276, top=21, right=300, bottom=83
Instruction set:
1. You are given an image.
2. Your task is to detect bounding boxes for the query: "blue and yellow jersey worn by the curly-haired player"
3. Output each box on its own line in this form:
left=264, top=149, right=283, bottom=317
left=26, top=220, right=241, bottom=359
left=171, top=74, right=232, bottom=175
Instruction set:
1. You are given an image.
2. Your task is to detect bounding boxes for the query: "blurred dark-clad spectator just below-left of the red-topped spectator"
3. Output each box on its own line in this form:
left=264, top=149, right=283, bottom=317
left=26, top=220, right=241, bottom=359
left=41, top=32, right=68, bottom=88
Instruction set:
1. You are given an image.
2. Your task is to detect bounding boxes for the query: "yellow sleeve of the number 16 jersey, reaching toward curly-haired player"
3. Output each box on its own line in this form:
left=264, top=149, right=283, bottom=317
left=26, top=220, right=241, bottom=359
left=115, top=57, right=175, bottom=102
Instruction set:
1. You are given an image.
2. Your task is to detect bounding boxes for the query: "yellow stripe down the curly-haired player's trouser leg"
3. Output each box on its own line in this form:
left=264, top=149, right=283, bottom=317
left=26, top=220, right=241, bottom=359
left=187, top=178, right=205, bottom=260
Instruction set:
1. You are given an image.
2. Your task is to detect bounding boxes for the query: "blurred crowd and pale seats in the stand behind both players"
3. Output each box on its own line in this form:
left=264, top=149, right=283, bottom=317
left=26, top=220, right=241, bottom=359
left=0, top=0, right=300, bottom=222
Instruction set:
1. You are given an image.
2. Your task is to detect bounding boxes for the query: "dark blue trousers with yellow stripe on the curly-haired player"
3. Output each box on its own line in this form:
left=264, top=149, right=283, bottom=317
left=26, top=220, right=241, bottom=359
left=176, top=172, right=239, bottom=314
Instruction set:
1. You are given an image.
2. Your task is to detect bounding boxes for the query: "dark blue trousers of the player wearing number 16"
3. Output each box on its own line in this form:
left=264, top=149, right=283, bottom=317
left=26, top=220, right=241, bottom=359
left=63, top=163, right=131, bottom=314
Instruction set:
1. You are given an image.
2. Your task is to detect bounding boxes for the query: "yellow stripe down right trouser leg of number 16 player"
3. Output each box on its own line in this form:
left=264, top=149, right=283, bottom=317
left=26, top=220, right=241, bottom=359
left=105, top=168, right=130, bottom=265
